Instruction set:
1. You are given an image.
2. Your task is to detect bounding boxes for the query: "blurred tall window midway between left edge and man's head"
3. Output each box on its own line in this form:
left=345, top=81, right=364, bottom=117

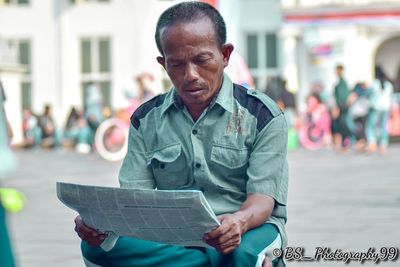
left=81, top=37, right=112, bottom=107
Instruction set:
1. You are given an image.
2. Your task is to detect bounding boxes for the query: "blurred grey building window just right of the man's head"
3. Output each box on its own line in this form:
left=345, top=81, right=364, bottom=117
left=246, top=32, right=279, bottom=90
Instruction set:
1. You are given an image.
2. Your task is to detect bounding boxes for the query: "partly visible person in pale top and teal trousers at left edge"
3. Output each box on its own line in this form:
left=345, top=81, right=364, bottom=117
left=0, top=81, right=15, bottom=267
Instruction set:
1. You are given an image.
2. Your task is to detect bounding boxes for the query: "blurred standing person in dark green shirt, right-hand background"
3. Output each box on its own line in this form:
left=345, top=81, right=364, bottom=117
left=333, top=65, right=350, bottom=152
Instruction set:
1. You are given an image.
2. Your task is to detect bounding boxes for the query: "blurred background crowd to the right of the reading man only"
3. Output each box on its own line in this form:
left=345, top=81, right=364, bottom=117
left=265, top=65, right=400, bottom=154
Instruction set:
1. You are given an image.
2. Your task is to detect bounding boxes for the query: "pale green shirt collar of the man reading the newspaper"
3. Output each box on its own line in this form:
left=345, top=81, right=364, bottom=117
left=161, top=73, right=233, bottom=114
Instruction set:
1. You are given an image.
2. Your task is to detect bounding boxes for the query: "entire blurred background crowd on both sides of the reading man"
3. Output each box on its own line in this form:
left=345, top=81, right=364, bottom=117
left=14, top=65, right=400, bottom=157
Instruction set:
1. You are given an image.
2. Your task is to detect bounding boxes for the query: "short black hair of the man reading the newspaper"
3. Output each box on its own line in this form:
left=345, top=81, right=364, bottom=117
left=155, top=1, right=226, bottom=55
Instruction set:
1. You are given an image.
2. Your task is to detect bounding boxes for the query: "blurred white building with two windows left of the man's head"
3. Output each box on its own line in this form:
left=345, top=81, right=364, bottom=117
left=0, top=0, right=180, bottom=143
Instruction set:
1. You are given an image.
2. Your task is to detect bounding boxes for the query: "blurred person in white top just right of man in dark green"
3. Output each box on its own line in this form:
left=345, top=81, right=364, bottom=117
left=348, top=82, right=370, bottom=151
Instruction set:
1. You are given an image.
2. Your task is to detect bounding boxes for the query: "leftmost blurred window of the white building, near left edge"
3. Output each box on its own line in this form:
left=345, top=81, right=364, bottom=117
left=8, top=39, right=32, bottom=109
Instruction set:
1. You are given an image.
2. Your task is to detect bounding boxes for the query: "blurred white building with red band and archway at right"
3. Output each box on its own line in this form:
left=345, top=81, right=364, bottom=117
left=281, top=0, right=400, bottom=110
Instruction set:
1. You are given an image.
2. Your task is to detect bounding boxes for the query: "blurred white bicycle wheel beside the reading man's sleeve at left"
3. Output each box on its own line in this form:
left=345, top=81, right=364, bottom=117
left=94, top=118, right=128, bottom=161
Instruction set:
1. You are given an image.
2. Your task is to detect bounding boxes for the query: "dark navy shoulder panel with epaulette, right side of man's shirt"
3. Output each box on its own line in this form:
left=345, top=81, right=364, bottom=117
left=233, top=84, right=282, bottom=131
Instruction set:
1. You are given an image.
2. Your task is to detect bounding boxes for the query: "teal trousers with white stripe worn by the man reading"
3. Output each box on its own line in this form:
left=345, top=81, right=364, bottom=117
left=81, top=224, right=281, bottom=267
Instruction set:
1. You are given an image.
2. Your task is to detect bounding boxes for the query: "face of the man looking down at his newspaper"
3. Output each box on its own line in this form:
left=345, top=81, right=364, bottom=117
left=157, top=18, right=233, bottom=110
